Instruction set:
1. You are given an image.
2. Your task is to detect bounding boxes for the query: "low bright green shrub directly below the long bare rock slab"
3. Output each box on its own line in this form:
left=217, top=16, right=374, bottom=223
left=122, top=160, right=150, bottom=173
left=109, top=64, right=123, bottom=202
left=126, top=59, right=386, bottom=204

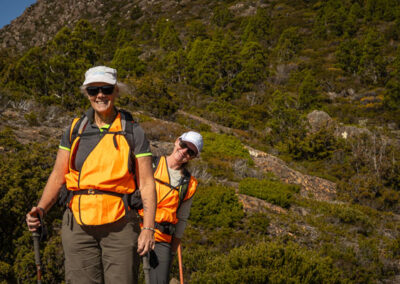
left=239, top=178, right=300, bottom=208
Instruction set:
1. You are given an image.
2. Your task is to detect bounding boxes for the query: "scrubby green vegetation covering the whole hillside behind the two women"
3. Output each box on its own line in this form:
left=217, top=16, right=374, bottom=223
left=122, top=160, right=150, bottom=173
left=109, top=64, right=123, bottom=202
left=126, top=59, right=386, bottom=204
left=0, top=0, right=400, bottom=283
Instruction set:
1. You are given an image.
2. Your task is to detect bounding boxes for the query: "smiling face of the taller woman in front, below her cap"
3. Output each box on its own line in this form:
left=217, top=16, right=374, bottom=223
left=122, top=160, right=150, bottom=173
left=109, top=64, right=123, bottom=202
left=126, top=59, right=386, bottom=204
left=85, top=82, right=118, bottom=115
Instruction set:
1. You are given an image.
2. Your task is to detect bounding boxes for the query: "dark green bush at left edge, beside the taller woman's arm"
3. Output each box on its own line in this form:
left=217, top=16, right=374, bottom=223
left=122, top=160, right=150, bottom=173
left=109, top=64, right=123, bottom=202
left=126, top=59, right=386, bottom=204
left=0, top=140, right=63, bottom=283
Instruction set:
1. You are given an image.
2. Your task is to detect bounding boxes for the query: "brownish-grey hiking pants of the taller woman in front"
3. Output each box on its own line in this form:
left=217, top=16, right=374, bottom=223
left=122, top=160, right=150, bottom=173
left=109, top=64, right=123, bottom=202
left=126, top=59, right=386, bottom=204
left=61, top=209, right=140, bottom=284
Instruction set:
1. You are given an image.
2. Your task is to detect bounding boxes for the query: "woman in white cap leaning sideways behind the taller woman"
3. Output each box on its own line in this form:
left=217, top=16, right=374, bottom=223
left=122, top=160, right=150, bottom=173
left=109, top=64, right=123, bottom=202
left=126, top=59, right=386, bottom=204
left=139, top=131, right=203, bottom=284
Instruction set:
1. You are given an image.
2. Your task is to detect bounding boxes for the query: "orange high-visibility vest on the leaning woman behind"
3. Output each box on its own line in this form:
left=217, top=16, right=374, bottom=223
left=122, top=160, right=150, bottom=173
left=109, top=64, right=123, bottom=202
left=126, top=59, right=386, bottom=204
left=139, top=156, right=198, bottom=243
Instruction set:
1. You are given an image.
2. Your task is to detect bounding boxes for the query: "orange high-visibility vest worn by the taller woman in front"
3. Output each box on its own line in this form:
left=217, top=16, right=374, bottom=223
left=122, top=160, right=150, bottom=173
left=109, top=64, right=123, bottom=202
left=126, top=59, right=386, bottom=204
left=65, top=113, right=136, bottom=226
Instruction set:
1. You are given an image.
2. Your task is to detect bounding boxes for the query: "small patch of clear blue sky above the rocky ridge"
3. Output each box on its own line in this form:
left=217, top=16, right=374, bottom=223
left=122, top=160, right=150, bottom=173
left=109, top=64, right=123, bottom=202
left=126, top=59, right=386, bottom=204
left=0, top=0, right=36, bottom=29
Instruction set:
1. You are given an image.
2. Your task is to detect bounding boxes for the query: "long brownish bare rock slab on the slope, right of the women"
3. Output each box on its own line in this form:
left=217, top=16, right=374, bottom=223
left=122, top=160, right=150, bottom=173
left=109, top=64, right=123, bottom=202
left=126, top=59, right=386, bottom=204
left=247, top=147, right=336, bottom=201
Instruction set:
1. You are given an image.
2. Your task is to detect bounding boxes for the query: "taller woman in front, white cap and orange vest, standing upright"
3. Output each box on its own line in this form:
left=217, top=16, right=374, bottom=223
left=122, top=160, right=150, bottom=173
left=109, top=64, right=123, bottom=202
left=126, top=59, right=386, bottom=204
left=26, top=66, right=156, bottom=284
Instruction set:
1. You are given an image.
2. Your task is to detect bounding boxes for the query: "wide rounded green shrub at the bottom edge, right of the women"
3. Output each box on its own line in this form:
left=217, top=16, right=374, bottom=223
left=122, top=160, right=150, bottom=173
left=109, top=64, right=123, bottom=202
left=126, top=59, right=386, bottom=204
left=191, top=242, right=346, bottom=284
